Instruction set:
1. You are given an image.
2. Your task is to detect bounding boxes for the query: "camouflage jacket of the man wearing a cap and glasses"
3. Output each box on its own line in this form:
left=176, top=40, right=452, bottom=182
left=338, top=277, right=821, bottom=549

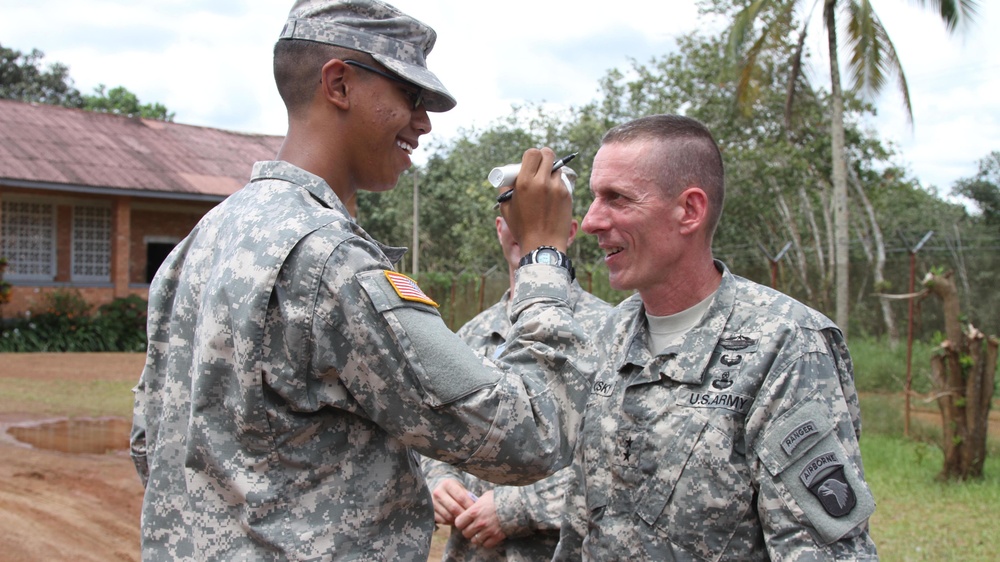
left=132, top=162, right=593, bottom=562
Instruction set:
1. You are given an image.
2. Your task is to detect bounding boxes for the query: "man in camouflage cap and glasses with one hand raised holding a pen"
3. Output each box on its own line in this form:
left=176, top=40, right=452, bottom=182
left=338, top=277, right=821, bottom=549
left=132, top=0, right=588, bottom=562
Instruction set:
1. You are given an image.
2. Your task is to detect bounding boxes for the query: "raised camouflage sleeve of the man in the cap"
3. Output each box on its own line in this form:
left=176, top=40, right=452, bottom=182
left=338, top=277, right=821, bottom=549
left=315, top=240, right=592, bottom=484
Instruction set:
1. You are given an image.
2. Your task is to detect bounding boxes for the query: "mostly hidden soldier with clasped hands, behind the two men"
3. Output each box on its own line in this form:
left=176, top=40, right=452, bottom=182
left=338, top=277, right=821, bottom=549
left=421, top=167, right=610, bottom=562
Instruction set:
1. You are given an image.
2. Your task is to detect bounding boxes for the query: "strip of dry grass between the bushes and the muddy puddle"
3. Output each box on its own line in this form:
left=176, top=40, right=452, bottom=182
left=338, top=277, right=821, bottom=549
left=0, top=378, right=135, bottom=419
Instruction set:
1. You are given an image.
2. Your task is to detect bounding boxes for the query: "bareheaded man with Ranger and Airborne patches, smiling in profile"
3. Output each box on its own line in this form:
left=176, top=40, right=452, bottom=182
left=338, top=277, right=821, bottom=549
left=557, top=115, right=876, bottom=561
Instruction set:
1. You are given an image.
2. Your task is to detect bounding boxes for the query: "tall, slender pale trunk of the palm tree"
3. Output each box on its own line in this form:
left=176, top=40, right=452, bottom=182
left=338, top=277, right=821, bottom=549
left=823, top=0, right=851, bottom=338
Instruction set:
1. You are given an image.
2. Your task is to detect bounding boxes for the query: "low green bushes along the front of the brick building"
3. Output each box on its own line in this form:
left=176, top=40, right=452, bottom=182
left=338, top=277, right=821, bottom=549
left=0, top=290, right=146, bottom=352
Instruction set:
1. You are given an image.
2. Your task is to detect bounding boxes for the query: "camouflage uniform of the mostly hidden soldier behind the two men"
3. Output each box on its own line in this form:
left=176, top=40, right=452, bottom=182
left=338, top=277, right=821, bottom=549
left=421, top=281, right=611, bottom=562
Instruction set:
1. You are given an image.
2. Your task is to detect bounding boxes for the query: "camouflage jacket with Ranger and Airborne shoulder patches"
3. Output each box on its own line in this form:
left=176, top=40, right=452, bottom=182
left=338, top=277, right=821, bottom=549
left=557, top=262, right=876, bottom=562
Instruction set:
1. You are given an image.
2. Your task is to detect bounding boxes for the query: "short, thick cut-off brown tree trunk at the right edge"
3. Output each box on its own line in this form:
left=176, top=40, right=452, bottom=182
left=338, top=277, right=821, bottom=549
left=924, top=273, right=1000, bottom=480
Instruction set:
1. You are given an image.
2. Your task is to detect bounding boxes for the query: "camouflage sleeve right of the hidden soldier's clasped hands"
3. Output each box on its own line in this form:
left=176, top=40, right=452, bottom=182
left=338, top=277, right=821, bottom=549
left=493, top=467, right=573, bottom=537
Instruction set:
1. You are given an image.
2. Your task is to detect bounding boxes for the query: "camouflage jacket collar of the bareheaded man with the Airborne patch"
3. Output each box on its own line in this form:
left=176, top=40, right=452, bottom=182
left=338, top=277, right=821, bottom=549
left=619, top=260, right=736, bottom=384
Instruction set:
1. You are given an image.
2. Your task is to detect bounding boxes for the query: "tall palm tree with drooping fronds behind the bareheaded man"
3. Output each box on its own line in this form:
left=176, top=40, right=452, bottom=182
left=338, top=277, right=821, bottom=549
left=728, top=0, right=978, bottom=335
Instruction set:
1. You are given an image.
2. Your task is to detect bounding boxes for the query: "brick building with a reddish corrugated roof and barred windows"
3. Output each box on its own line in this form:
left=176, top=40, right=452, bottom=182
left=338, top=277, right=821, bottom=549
left=0, top=100, right=283, bottom=317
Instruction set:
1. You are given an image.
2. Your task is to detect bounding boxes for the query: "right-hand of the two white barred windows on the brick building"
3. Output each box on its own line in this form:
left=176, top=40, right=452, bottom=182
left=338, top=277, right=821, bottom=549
left=72, top=205, right=111, bottom=281
